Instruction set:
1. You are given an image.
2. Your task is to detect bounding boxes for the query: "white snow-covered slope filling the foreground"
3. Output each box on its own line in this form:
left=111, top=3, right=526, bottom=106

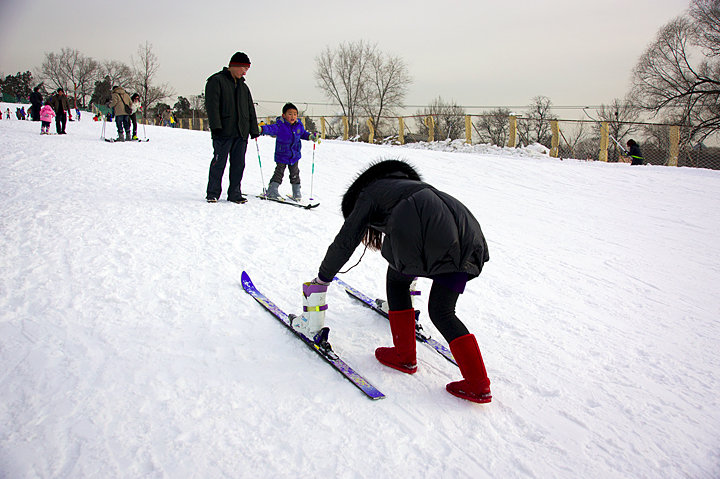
left=0, top=104, right=720, bottom=478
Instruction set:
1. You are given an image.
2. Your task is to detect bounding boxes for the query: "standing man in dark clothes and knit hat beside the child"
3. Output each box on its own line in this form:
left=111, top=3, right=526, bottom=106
left=205, top=52, right=260, bottom=203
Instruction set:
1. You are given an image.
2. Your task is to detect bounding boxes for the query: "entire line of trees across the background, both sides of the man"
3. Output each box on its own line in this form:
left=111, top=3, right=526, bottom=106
left=0, top=0, right=720, bottom=154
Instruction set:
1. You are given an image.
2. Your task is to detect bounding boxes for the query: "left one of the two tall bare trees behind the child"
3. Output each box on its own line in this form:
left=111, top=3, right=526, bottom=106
left=315, top=40, right=376, bottom=133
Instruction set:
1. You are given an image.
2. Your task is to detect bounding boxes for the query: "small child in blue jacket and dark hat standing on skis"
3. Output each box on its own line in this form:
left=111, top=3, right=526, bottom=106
left=260, top=103, right=317, bottom=201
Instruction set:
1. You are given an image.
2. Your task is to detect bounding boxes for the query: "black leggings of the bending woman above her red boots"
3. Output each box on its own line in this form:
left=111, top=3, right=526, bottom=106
left=386, top=267, right=469, bottom=343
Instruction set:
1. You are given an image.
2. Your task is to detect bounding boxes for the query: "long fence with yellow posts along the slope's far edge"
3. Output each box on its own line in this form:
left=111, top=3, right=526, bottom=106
left=153, top=115, right=720, bottom=169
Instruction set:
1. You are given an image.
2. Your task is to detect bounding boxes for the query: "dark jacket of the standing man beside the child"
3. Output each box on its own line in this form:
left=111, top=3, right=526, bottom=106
left=205, top=67, right=260, bottom=139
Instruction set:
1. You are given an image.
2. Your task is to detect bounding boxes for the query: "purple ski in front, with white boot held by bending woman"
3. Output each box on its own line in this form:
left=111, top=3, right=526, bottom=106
left=242, top=271, right=385, bottom=399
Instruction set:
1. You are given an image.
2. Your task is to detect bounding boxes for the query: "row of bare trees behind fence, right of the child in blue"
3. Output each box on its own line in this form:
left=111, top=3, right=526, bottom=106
left=315, top=0, right=720, bottom=158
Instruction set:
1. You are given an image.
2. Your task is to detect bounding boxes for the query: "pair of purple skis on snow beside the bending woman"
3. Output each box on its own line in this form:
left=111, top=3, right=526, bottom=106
left=241, top=271, right=457, bottom=400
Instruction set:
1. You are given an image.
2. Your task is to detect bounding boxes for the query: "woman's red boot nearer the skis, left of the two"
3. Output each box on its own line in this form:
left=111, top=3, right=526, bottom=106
left=375, top=309, right=417, bottom=374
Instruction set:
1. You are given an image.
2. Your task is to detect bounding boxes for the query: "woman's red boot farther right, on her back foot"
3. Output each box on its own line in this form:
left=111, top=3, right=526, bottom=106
left=445, top=334, right=492, bottom=403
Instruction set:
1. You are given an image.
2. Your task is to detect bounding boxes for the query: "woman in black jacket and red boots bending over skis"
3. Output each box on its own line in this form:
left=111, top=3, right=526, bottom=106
left=292, top=160, right=492, bottom=403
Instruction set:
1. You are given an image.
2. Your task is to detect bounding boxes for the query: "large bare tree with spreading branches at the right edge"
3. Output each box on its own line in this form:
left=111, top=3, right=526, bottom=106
left=631, top=0, right=720, bottom=138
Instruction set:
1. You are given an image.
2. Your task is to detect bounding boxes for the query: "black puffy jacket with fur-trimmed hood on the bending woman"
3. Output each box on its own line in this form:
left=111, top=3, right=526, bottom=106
left=319, top=160, right=490, bottom=279
